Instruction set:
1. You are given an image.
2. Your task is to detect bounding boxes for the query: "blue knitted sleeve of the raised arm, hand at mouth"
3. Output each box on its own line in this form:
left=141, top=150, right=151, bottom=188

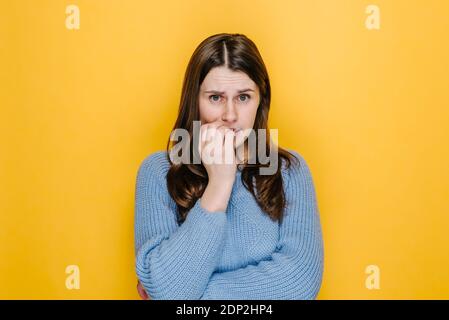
left=135, top=153, right=226, bottom=300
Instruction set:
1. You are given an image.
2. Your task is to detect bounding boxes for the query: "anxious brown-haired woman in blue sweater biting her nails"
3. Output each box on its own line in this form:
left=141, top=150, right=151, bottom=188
left=135, top=34, right=323, bottom=300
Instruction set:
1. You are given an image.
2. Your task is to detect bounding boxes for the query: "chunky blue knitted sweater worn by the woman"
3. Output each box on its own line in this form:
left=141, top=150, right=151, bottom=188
left=135, top=150, right=323, bottom=300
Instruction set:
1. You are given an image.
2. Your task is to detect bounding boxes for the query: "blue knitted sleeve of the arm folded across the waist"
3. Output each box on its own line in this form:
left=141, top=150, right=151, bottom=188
left=200, top=151, right=324, bottom=300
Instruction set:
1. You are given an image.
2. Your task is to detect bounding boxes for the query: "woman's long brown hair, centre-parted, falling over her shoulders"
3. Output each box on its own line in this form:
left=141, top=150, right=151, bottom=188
left=167, top=33, right=295, bottom=223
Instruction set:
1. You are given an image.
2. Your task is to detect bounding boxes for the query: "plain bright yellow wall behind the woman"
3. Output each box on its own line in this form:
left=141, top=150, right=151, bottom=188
left=0, top=0, right=449, bottom=299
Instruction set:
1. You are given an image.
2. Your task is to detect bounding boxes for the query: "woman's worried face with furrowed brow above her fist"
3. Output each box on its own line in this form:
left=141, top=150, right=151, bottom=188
left=199, top=66, right=260, bottom=148
